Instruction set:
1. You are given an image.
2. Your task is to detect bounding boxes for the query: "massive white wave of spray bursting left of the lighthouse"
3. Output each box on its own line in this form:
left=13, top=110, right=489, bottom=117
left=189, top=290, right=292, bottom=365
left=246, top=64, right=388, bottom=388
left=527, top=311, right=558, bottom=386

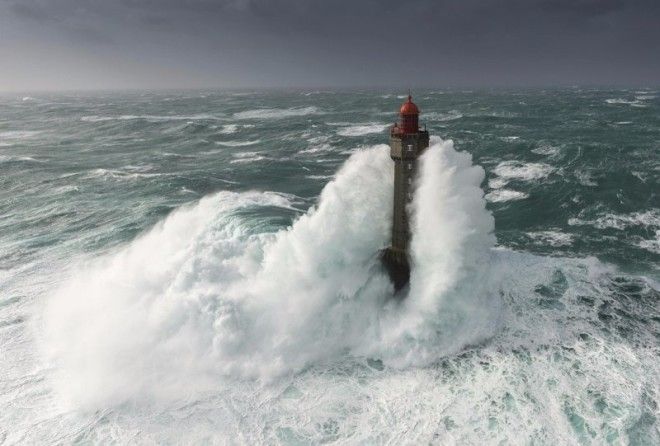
left=45, top=147, right=391, bottom=403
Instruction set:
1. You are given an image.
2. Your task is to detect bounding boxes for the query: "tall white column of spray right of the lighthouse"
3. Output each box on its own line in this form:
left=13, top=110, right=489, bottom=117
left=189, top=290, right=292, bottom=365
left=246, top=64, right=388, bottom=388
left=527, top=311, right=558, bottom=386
left=383, top=137, right=500, bottom=366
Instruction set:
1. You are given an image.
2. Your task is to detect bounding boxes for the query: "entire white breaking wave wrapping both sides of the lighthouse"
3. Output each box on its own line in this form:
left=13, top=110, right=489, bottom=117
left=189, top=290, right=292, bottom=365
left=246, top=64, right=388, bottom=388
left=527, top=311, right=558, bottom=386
left=44, top=139, right=497, bottom=407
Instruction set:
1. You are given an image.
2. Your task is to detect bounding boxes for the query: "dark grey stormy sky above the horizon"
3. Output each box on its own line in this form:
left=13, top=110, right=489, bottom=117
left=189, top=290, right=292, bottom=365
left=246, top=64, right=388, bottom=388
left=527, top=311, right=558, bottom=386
left=0, top=0, right=660, bottom=91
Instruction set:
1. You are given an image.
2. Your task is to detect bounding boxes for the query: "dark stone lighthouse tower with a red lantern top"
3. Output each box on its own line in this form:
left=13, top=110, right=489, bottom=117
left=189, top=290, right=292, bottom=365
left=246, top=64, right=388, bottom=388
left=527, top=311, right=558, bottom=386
left=382, top=95, right=429, bottom=291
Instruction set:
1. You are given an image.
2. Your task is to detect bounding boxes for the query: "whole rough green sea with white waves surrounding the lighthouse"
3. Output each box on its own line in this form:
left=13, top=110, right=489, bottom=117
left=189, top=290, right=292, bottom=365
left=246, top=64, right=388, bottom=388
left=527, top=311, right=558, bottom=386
left=0, top=87, right=660, bottom=445
